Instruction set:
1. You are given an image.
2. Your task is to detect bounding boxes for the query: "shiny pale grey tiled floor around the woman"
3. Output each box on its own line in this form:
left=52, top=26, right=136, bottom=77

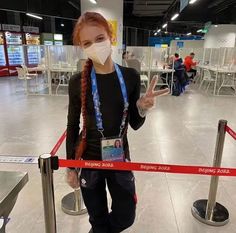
left=0, top=78, right=236, bottom=233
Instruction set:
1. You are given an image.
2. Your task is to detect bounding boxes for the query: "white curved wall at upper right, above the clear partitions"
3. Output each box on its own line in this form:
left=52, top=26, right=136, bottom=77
left=204, top=24, right=236, bottom=48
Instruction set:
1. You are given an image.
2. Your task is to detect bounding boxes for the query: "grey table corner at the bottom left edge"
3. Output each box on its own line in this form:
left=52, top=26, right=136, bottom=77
left=0, top=171, right=28, bottom=233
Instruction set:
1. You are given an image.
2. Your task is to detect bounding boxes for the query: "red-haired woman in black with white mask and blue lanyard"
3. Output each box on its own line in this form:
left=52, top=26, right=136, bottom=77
left=66, top=12, right=168, bottom=233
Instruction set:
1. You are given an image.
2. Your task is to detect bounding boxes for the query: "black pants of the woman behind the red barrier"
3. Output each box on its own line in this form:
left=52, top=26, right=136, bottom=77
left=80, top=169, right=136, bottom=233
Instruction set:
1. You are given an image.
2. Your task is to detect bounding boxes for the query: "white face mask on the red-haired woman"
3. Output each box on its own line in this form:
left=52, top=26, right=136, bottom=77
left=84, top=39, right=111, bottom=65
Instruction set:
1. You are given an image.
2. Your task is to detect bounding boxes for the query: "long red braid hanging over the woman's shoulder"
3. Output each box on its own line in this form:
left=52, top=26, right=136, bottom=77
left=75, top=59, right=93, bottom=159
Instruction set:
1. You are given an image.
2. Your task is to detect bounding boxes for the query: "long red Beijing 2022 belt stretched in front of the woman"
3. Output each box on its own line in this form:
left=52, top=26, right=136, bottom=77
left=59, top=159, right=236, bottom=176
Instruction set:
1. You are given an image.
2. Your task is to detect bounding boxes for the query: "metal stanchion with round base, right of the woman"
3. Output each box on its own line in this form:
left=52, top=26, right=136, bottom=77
left=192, top=120, right=229, bottom=226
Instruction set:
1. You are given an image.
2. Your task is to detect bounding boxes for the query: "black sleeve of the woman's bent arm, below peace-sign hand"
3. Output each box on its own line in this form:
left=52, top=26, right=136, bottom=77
left=129, top=70, right=145, bottom=130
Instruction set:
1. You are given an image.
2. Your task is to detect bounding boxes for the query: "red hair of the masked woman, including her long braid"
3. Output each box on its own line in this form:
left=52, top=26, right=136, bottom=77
left=73, top=12, right=112, bottom=159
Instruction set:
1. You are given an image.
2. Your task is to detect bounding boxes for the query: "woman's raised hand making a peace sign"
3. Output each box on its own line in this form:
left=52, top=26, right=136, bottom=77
left=137, top=76, right=169, bottom=111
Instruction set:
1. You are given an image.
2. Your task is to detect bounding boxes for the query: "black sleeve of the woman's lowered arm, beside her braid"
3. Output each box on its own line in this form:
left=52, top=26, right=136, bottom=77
left=66, top=74, right=81, bottom=159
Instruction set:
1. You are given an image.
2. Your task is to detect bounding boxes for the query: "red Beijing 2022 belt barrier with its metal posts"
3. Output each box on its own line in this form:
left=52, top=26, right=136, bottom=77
left=39, top=120, right=236, bottom=233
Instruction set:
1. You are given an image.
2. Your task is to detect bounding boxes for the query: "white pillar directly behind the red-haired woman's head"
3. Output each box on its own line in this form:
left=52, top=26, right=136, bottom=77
left=81, top=0, right=123, bottom=64
